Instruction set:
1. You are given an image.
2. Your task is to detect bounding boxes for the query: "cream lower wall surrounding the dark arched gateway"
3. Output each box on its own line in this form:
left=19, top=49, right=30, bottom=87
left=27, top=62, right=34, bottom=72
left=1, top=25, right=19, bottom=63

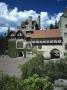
left=37, top=45, right=63, bottom=58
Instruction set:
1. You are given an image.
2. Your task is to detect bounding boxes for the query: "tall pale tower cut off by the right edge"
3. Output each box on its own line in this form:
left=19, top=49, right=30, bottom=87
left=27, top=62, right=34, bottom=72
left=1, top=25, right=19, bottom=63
left=59, top=8, right=67, bottom=55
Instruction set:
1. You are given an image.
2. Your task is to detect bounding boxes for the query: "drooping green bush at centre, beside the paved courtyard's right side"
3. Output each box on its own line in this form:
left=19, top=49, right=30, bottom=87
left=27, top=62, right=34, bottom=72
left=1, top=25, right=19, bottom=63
left=20, top=55, right=44, bottom=78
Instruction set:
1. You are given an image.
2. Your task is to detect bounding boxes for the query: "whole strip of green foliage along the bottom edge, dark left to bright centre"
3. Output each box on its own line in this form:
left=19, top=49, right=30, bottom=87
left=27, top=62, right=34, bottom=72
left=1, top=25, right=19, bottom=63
left=0, top=74, right=53, bottom=90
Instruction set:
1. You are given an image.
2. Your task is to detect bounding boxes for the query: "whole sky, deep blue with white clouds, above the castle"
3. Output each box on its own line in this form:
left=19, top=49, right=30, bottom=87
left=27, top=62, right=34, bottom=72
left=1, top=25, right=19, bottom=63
left=0, top=0, right=67, bottom=32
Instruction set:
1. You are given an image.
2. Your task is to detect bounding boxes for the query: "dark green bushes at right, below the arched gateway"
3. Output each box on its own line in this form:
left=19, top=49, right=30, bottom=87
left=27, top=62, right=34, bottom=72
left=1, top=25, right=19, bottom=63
left=44, top=60, right=67, bottom=81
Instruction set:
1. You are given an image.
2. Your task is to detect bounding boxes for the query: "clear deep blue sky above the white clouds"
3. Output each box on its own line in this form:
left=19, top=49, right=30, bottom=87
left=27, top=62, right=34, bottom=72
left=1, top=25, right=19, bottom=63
left=0, top=0, right=67, bottom=13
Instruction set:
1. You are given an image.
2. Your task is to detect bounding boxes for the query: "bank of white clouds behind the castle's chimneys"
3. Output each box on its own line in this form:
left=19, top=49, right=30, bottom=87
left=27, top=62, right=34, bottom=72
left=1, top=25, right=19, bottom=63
left=0, top=2, right=62, bottom=32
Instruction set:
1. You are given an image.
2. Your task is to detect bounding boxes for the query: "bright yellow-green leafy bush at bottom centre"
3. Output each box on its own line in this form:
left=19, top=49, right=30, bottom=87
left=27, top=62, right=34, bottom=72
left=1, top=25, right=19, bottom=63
left=20, top=74, right=53, bottom=90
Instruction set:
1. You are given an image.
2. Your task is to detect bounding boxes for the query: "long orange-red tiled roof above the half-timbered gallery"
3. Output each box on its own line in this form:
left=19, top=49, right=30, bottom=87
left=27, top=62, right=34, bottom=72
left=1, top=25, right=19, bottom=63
left=32, top=29, right=61, bottom=38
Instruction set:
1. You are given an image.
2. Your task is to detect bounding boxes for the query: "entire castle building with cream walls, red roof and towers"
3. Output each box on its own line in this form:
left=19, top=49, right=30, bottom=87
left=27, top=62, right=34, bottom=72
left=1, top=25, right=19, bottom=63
left=8, top=9, right=67, bottom=58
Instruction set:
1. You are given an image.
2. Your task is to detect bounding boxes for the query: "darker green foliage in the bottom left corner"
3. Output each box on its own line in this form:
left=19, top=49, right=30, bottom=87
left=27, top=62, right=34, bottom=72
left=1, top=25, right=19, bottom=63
left=0, top=74, right=18, bottom=90
